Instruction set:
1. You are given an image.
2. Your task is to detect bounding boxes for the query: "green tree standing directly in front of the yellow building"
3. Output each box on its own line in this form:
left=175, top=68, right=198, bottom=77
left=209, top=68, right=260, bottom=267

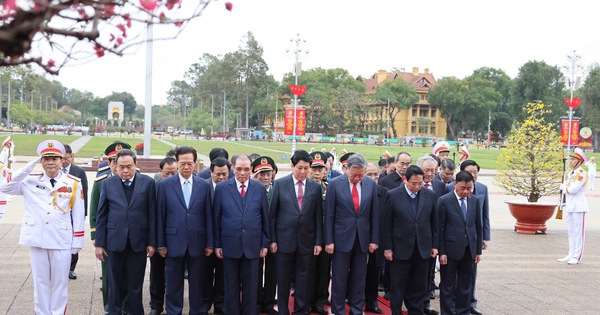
left=373, top=78, right=419, bottom=138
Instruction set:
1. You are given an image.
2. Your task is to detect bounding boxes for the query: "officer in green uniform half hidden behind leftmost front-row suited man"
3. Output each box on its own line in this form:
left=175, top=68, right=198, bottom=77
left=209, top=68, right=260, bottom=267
left=89, top=141, right=131, bottom=314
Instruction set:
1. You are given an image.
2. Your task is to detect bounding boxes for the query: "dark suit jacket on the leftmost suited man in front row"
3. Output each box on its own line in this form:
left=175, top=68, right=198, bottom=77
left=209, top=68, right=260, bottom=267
left=96, top=173, right=157, bottom=252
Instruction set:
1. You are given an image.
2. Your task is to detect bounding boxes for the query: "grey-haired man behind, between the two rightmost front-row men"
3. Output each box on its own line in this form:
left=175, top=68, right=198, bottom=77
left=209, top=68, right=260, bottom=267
left=417, top=154, right=452, bottom=315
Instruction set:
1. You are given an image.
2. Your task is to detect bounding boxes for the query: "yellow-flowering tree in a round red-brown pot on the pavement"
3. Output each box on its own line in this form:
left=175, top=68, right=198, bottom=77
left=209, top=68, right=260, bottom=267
left=495, top=101, right=564, bottom=234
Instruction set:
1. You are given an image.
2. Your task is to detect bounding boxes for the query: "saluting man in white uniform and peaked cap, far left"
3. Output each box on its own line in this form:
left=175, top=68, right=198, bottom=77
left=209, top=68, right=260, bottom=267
left=0, top=140, right=85, bottom=314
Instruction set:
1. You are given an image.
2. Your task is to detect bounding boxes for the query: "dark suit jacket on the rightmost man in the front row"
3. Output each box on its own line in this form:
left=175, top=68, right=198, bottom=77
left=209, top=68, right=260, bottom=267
left=437, top=193, right=483, bottom=260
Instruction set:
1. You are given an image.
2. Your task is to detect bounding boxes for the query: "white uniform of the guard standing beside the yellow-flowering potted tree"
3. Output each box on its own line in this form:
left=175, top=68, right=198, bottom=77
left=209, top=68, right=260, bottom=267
left=563, top=166, right=588, bottom=264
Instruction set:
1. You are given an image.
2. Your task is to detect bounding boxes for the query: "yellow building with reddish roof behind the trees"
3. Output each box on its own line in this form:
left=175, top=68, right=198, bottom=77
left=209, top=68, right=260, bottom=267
left=363, top=67, right=446, bottom=139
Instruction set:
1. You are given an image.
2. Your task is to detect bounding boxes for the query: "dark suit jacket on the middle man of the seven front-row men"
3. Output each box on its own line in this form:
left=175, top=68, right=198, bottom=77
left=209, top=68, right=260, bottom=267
left=269, top=174, right=323, bottom=254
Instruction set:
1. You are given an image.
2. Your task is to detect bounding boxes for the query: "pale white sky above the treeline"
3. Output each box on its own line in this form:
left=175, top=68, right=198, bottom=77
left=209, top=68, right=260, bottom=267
left=57, top=0, right=600, bottom=104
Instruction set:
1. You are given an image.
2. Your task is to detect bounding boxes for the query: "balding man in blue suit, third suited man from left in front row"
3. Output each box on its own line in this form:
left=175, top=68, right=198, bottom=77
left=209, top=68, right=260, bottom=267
left=214, top=154, right=269, bottom=315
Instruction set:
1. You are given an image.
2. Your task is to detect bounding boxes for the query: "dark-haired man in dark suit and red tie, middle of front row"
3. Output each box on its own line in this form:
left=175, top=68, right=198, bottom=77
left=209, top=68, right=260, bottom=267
left=269, top=150, right=323, bottom=315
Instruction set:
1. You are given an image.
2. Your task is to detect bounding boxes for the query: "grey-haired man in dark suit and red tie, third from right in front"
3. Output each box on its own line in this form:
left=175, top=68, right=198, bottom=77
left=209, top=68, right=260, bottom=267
left=324, top=154, right=379, bottom=315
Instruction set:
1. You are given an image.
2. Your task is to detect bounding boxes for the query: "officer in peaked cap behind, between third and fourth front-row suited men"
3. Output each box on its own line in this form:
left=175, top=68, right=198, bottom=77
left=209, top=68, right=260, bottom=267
left=252, top=156, right=277, bottom=314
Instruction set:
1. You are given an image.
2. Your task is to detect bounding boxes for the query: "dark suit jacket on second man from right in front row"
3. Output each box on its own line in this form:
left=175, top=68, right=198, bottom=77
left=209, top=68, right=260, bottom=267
left=383, top=185, right=439, bottom=260
